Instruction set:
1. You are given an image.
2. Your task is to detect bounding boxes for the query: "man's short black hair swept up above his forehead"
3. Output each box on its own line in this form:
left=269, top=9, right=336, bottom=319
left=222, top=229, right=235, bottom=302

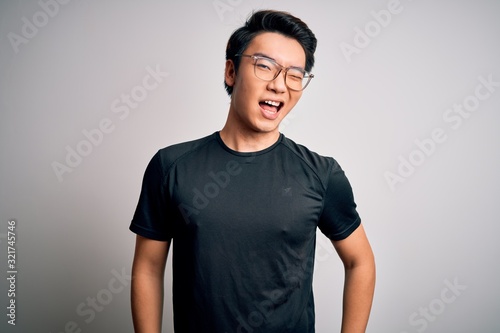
left=224, top=10, right=317, bottom=95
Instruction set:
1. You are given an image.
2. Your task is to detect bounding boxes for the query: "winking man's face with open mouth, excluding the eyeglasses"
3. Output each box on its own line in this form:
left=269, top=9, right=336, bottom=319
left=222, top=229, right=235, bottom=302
left=225, top=32, right=306, bottom=133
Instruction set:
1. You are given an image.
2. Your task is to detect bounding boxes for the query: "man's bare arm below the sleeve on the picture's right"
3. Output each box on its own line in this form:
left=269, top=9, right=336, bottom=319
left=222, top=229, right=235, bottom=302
left=332, top=225, right=375, bottom=333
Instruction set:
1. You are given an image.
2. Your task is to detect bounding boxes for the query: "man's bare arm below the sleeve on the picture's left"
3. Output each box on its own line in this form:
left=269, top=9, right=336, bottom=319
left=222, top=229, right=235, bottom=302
left=131, top=235, right=170, bottom=333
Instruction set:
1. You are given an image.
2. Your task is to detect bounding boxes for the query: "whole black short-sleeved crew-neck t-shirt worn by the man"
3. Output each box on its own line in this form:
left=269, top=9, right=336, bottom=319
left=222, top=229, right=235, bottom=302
left=130, top=132, right=360, bottom=333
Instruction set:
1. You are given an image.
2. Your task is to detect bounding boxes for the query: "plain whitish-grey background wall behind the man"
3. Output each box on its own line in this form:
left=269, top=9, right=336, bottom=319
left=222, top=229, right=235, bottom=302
left=0, top=0, right=500, bottom=333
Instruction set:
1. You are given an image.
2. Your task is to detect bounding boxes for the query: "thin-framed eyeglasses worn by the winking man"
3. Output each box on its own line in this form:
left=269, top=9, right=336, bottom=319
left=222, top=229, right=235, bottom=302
left=235, top=54, right=314, bottom=91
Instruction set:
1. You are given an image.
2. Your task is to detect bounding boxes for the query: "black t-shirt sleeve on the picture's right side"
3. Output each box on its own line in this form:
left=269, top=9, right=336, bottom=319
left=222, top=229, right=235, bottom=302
left=318, top=161, right=361, bottom=240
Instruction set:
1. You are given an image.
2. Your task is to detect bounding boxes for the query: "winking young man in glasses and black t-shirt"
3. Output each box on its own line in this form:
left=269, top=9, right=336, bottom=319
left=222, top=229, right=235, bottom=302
left=130, top=11, right=375, bottom=333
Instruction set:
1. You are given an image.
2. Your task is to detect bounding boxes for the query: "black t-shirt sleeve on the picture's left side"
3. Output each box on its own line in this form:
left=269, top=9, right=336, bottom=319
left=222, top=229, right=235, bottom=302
left=129, top=152, right=172, bottom=241
